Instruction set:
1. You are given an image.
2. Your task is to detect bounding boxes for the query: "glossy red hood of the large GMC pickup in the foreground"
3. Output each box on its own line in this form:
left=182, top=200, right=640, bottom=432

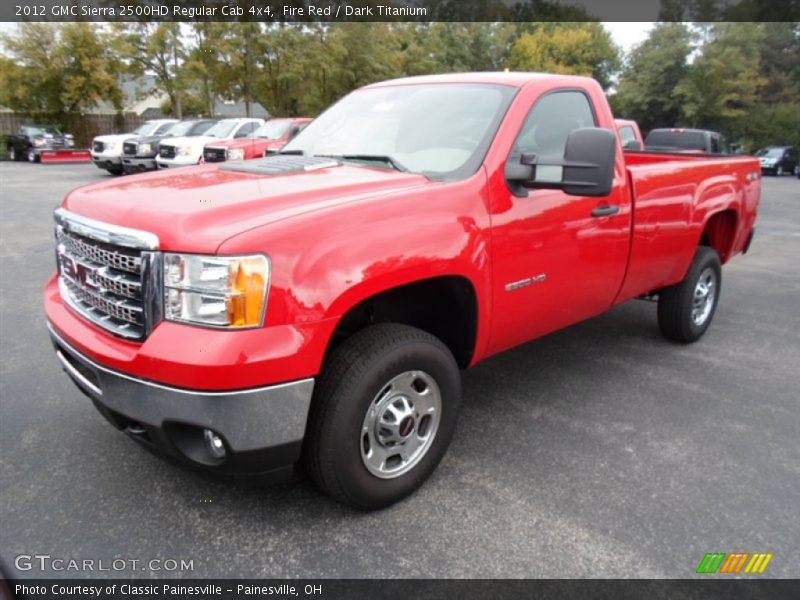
left=64, top=162, right=436, bottom=253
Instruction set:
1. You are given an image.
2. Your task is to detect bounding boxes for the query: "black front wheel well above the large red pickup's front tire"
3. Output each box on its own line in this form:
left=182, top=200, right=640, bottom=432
left=326, top=276, right=478, bottom=369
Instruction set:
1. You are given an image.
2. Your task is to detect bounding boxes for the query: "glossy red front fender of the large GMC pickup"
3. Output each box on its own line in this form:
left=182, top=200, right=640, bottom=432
left=219, top=169, right=491, bottom=366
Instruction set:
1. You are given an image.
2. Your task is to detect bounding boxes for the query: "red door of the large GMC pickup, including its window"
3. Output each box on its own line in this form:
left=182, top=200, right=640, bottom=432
left=489, top=90, right=631, bottom=353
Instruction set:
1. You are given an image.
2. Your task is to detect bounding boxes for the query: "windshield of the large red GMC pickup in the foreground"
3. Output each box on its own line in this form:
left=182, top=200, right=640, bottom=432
left=283, top=84, right=516, bottom=177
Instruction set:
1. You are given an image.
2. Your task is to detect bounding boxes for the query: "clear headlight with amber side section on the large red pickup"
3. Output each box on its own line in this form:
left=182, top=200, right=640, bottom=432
left=164, top=254, right=270, bottom=329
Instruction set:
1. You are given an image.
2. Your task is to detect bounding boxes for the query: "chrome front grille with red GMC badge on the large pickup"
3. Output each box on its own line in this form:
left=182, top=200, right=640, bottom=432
left=56, top=209, right=162, bottom=340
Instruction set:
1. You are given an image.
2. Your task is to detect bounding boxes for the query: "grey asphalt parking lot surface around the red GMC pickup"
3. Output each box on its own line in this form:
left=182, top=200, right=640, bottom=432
left=0, top=162, right=800, bottom=578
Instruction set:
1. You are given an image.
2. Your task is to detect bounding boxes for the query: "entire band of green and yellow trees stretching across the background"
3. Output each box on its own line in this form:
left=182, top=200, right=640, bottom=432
left=0, top=21, right=800, bottom=148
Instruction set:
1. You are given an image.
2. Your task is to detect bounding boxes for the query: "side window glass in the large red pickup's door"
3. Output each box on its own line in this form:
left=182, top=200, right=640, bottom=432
left=514, top=91, right=597, bottom=157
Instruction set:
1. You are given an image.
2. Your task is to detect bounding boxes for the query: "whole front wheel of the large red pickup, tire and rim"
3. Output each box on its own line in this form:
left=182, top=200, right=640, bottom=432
left=304, top=323, right=461, bottom=510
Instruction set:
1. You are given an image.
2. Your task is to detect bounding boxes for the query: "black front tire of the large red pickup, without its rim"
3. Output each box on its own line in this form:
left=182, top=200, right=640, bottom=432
left=304, top=323, right=461, bottom=510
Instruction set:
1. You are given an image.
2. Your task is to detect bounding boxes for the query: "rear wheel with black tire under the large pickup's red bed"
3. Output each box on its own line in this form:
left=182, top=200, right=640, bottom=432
left=658, top=246, right=722, bottom=344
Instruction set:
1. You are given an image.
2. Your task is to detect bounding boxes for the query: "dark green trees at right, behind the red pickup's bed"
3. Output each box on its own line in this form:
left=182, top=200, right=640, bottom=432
left=612, top=23, right=800, bottom=150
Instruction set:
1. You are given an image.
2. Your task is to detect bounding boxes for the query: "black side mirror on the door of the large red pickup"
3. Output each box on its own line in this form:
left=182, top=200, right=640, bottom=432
left=505, top=127, right=617, bottom=197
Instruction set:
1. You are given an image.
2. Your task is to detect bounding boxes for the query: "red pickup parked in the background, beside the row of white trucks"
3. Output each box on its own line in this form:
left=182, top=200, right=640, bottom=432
left=203, top=117, right=312, bottom=162
